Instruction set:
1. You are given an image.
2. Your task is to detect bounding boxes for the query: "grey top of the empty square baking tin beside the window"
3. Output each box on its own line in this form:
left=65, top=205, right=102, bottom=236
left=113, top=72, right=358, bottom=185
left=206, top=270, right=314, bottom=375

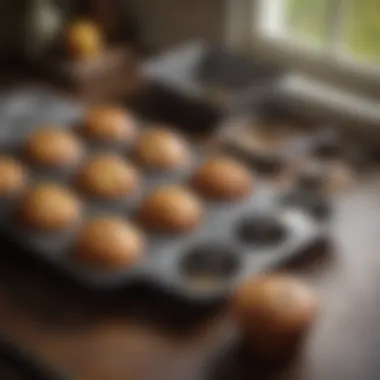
left=141, top=41, right=284, bottom=97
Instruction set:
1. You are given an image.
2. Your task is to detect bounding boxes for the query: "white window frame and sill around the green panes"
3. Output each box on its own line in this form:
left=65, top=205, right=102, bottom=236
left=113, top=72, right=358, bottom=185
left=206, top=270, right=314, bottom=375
left=226, top=0, right=380, bottom=98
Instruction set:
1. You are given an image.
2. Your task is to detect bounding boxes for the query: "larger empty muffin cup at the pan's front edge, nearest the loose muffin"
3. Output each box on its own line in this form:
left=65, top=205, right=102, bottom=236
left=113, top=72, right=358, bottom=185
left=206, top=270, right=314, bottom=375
left=180, top=243, right=240, bottom=289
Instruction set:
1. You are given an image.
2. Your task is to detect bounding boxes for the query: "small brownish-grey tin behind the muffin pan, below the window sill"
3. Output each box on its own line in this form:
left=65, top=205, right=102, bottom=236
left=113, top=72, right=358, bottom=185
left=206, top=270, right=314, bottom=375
left=221, top=86, right=339, bottom=173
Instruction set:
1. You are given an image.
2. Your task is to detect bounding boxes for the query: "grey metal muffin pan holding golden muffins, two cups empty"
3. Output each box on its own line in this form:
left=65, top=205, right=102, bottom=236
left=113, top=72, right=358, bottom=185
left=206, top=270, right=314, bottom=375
left=0, top=87, right=324, bottom=301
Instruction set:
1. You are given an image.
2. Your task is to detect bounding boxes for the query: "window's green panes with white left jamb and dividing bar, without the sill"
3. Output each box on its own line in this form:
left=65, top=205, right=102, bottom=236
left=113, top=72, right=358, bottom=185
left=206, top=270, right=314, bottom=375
left=259, top=0, right=380, bottom=63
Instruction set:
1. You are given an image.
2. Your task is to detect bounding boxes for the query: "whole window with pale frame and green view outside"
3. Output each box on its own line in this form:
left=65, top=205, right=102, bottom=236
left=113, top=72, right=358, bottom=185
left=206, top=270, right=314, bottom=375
left=227, top=0, right=380, bottom=98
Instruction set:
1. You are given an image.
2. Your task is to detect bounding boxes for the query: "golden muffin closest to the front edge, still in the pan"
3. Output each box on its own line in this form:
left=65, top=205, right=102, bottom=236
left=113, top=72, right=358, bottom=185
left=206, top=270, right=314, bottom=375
left=75, top=216, right=144, bottom=269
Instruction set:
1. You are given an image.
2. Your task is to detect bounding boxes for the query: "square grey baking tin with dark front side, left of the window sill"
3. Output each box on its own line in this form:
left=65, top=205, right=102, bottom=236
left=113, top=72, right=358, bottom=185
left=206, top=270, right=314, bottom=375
left=140, top=41, right=283, bottom=134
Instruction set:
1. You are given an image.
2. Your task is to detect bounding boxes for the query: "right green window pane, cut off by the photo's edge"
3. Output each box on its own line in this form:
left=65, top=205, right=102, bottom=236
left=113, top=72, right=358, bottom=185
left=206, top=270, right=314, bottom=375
left=343, top=0, right=380, bottom=62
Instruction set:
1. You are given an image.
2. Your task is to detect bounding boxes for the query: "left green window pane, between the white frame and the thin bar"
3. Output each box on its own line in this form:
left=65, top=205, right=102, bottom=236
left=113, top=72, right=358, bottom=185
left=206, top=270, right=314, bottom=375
left=284, top=0, right=330, bottom=44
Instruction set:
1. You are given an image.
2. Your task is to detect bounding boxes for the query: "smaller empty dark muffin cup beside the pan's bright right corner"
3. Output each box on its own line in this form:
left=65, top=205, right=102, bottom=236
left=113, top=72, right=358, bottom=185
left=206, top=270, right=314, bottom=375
left=237, top=215, right=287, bottom=247
